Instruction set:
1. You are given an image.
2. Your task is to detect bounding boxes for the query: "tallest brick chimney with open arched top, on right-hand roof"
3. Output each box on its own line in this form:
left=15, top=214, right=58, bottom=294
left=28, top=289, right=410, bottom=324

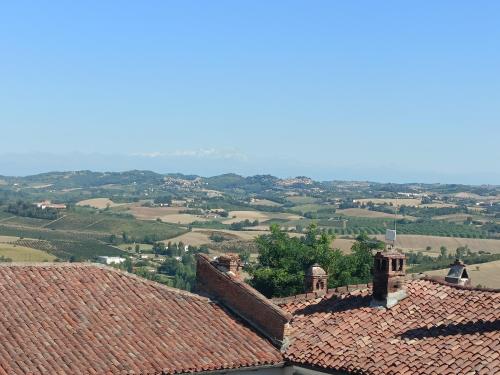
left=371, top=251, right=406, bottom=308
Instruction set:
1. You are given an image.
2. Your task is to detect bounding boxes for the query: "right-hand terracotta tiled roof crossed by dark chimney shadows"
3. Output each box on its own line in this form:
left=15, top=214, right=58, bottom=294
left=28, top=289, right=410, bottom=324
left=280, top=280, right=500, bottom=374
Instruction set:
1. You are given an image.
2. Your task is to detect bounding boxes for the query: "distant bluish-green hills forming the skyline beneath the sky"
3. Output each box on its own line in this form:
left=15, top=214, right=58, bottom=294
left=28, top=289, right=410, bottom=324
left=0, top=170, right=500, bottom=195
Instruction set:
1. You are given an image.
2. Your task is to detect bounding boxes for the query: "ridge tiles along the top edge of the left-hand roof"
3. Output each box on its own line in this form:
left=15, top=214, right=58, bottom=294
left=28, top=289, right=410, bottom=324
left=0, top=262, right=210, bottom=301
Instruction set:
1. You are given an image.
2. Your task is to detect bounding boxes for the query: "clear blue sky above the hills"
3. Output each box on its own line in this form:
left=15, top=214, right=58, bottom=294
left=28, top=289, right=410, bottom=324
left=0, top=0, right=500, bottom=184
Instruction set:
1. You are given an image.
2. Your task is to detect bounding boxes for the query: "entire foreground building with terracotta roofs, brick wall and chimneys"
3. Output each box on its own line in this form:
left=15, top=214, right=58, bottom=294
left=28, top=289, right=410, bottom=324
left=0, top=252, right=500, bottom=375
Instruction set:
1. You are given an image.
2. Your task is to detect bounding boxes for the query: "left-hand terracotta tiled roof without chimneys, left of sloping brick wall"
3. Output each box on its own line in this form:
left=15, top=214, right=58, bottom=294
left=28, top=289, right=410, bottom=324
left=0, top=264, right=283, bottom=375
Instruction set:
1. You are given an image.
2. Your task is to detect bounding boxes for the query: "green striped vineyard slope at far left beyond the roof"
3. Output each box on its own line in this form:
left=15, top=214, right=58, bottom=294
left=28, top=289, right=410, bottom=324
left=0, top=209, right=187, bottom=261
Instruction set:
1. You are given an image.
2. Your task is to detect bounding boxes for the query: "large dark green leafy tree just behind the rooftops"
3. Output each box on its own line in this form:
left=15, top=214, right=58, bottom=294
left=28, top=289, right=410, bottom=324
left=248, top=228, right=383, bottom=297
